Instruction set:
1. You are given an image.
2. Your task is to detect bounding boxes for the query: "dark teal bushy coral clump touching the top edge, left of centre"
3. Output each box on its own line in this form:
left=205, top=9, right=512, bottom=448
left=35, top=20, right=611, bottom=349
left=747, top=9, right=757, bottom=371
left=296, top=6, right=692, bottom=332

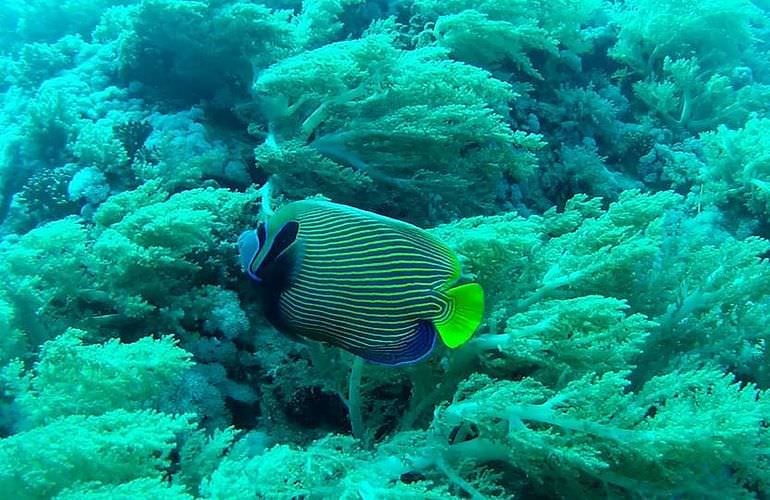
left=120, top=0, right=295, bottom=104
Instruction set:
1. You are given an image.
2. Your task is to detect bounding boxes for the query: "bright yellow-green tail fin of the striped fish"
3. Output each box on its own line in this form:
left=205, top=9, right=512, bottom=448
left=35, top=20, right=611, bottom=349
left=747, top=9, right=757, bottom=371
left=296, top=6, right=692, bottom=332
left=436, top=283, right=484, bottom=348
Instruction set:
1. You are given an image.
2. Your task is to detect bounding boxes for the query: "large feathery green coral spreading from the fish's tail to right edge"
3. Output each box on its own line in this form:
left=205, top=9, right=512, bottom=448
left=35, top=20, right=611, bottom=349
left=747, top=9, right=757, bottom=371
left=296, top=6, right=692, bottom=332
left=437, top=192, right=770, bottom=387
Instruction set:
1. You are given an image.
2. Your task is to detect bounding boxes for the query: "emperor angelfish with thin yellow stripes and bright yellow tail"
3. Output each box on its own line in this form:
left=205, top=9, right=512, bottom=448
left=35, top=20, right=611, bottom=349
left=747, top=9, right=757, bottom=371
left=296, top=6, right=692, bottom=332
left=238, top=200, right=484, bottom=365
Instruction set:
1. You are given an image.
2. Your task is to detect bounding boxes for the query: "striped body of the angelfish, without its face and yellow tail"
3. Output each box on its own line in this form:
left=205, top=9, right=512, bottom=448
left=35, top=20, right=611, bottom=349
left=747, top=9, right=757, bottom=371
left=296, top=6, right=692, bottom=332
left=278, top=202, right=459, bottom=353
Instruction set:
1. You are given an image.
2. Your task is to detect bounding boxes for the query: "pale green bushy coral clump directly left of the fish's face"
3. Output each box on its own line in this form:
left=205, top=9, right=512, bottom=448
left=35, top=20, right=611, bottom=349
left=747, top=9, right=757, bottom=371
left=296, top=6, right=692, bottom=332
left=93, top=183, right=258, bottom=336
